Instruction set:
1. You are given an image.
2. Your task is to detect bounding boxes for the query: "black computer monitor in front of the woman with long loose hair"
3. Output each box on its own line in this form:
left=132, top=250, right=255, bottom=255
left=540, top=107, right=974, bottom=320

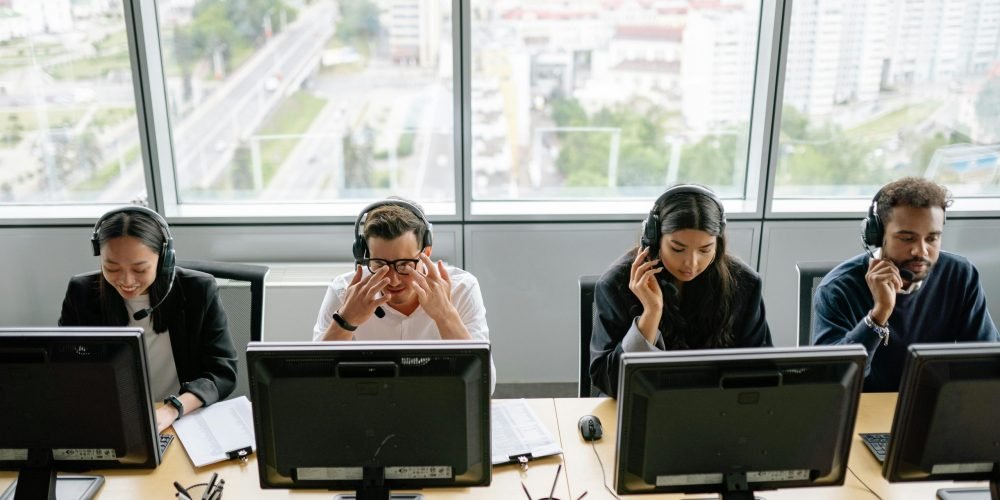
left=615, top=345, right=866, bottom=500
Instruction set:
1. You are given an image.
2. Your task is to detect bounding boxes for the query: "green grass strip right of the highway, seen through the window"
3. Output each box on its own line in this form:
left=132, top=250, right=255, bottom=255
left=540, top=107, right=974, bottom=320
left=257, top=91, right=326, bottom=185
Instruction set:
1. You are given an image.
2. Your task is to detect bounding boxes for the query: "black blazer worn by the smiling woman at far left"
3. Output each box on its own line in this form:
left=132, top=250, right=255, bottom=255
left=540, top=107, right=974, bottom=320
left=59, top=267, right=236, bottom=406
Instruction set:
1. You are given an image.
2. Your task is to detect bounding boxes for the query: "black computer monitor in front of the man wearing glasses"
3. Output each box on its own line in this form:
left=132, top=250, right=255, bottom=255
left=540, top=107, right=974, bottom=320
left=247, top=341, right=491, bottom=500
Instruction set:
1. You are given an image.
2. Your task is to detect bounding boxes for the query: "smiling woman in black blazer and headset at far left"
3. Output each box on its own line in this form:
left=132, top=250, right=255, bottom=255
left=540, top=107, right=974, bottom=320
left=59, top=206, right=236, bottom=431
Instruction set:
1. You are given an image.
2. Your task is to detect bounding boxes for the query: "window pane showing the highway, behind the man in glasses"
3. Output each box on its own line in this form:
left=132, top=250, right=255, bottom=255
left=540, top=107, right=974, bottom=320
left=158, top=0, right=455, bottom=203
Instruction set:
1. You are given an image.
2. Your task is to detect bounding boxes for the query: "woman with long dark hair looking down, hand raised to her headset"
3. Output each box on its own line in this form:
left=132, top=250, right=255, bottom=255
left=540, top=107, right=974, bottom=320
left=590, top=184, right=772, bottom=397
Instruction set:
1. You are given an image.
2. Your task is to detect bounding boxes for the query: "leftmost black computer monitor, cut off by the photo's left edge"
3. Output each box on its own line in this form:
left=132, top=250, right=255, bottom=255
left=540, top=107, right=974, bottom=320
left=0, top=327, right=160, bottom=500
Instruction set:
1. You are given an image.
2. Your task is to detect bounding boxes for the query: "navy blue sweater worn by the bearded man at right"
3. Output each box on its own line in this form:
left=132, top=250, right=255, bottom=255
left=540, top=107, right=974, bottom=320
left=813, top=252, right=1000, bottom=391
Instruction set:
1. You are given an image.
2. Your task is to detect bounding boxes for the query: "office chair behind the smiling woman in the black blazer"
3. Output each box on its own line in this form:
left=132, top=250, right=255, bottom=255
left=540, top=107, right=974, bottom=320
left=177, top=260, right=270, bottom=399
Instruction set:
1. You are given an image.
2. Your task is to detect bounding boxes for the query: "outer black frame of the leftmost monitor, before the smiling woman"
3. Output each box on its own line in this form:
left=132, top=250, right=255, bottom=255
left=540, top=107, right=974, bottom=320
left=0, top=327, right=163, bottom=472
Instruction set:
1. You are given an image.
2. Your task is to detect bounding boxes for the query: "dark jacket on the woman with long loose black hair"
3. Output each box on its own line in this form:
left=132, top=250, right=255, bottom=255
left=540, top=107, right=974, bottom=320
left=590, top=251, right=772, bottom=397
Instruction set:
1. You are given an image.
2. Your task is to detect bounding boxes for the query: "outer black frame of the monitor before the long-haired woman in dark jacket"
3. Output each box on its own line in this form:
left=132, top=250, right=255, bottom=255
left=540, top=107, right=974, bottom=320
left=615, top=345, right=867, bottom=494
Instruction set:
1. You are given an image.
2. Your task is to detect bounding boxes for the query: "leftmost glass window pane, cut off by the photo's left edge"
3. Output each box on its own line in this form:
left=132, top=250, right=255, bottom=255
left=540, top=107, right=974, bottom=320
left=0, top=0, right=146, bottom=204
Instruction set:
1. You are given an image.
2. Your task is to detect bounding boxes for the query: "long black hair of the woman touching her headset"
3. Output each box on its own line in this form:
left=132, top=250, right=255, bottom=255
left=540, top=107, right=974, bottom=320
left=623, top=192, right=740, bottom=349
